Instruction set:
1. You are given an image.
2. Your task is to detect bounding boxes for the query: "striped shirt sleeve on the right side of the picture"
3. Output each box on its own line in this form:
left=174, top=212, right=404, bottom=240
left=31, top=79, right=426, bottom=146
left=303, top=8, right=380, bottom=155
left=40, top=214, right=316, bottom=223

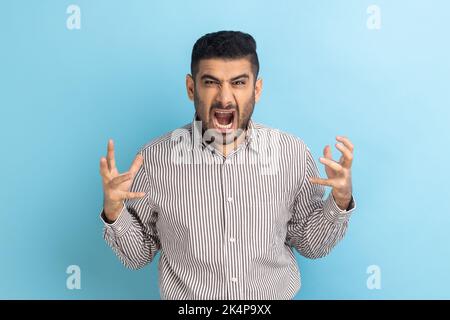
left=286, top=148, right=356, bottom=259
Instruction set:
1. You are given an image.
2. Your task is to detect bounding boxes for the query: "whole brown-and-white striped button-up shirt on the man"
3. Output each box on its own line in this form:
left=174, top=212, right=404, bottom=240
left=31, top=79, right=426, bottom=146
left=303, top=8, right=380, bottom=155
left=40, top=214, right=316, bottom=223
left=101, top=116, right=355, bottom=300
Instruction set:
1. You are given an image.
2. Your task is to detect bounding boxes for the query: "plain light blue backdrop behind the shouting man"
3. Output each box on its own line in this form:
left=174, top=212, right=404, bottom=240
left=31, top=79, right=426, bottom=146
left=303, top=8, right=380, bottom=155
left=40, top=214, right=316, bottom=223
left=0, top=0, right=450, bottom=299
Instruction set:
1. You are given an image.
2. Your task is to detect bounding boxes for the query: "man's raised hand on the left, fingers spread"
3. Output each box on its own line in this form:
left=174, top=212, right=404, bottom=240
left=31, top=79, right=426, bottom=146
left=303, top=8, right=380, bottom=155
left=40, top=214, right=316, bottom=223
left=100, top=139, right=145, bottom=222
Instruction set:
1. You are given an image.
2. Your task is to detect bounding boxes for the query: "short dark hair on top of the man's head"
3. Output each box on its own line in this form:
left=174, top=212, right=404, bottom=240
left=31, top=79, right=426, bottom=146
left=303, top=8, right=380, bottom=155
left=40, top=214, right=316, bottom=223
left=191, top=31, right=259, bottom=81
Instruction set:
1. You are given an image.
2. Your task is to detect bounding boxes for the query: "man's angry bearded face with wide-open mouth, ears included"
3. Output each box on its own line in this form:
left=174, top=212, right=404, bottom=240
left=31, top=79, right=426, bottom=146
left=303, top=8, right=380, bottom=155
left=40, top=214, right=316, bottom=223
left=186, top=58, right=262, bottom=144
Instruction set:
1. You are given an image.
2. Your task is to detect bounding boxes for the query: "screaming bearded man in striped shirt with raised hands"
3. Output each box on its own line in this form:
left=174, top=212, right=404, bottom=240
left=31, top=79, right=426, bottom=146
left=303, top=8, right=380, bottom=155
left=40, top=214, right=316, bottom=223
left=100, top=31, right=355, bottom=299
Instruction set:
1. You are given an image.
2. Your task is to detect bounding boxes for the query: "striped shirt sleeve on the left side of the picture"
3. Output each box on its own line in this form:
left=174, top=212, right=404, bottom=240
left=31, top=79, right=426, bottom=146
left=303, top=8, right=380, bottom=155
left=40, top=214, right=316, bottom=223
left=100, top=149, right=161, bottom=269
